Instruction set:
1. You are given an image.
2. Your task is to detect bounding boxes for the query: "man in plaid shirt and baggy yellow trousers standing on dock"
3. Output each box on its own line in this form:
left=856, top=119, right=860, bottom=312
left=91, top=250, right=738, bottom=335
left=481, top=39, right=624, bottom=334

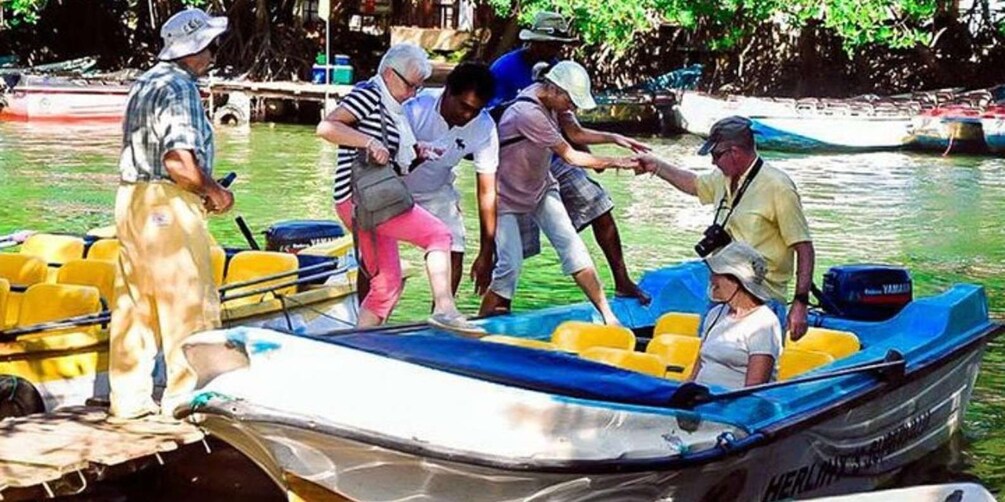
left=109, top=9, right=234, bottom=420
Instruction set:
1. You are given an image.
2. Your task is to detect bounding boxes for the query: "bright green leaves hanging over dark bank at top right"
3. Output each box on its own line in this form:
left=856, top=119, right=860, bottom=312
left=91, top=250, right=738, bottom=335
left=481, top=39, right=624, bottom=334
left=484, top=0, right=939, bottom=53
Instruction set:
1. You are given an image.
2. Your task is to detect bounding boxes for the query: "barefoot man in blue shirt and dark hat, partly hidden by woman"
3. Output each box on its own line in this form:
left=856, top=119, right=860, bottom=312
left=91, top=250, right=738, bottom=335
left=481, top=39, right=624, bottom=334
left=491, top=12, right=650, bottom=304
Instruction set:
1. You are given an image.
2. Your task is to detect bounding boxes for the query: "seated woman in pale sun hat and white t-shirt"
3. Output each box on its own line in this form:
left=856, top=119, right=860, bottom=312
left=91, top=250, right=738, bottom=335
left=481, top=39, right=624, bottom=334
left=690, top=241, right=782, bottom=389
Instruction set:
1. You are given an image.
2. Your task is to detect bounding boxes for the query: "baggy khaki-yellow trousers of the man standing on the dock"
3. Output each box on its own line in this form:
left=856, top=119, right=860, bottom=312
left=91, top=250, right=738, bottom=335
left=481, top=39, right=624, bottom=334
left=109, top=182, right=220, bottom=417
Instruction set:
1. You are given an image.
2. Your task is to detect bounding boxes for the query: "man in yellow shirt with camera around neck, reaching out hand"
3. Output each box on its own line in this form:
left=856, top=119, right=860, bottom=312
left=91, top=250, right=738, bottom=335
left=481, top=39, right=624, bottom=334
left=638, top=116, right=815, bottom=339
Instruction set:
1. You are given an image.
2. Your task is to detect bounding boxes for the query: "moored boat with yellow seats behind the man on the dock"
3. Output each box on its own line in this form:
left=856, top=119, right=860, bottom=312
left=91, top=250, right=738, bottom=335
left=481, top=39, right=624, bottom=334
left=0, top=222, right=358, bottom=412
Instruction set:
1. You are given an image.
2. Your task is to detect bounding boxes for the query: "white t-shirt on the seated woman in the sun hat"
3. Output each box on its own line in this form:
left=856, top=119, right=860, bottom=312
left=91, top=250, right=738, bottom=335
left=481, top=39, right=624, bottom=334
left=694, top=304, right=782, bottom=389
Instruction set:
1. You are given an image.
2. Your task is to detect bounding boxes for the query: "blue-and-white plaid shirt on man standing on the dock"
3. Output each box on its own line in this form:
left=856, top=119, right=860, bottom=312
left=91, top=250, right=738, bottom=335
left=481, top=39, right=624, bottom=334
left=119, top=61, right=213, bottom=183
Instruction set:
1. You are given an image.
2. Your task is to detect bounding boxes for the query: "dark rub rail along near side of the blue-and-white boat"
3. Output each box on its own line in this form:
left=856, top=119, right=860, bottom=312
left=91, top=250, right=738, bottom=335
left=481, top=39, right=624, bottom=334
left=184, top=321, right=1005, bottom=475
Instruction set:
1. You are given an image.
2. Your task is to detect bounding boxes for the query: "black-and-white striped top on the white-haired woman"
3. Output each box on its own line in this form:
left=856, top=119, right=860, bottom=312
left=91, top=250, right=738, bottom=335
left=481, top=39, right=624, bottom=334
left=333, top=81, right=408, bottom=204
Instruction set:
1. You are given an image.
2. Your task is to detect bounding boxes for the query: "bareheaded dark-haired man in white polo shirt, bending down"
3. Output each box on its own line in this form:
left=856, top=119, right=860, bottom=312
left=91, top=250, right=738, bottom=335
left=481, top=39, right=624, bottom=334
left=404, top=62, right=499, bottom=294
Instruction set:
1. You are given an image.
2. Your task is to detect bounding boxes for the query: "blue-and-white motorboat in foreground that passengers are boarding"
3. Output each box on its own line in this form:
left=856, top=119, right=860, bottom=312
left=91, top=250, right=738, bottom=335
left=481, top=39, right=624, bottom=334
left=176, top=262, right=1003, bottom=501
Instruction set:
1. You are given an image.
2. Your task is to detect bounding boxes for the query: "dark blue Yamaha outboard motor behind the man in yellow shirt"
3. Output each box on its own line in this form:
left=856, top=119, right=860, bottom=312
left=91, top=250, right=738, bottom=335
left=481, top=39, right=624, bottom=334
left=814, top=264, right=914, bottom=320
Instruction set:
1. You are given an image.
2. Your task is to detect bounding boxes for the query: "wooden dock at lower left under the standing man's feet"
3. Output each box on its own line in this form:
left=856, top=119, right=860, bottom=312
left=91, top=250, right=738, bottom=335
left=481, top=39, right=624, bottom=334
left=0, top=407, right=204, bottom=500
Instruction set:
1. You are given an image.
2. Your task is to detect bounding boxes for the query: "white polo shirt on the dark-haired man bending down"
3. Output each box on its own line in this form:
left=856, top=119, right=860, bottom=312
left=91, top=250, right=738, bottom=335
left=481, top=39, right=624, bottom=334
left=404, top=89, right=499, bottom=194
